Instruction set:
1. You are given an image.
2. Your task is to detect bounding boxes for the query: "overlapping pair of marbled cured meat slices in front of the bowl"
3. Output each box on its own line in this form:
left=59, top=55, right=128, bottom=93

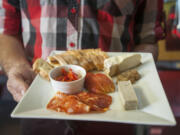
left=47, top=91, right=112, bottom=114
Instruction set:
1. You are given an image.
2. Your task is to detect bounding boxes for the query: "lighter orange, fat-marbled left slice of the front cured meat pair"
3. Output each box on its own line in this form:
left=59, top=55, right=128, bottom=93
left=47, top=92, right=90, bottom=114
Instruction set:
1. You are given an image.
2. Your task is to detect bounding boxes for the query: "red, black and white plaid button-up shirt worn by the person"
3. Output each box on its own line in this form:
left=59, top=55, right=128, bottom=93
left=0, top=0, right=163, bottom=61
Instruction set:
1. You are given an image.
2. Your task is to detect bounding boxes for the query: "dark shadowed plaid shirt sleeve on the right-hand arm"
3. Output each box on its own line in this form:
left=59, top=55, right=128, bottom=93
left=134, top=0, right=164, bottom=44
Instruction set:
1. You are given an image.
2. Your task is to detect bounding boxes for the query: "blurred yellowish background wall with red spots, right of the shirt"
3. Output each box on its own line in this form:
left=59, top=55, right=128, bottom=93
left=158, top=0, right=180, bottom=69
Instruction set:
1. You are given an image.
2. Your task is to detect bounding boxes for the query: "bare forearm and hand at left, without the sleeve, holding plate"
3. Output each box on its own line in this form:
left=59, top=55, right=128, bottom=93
left=0, top=34, right=35, bottom=101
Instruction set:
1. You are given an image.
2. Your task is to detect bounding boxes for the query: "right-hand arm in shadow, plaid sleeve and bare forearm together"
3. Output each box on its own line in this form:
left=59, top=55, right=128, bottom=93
left=134, top=0, right=163, bottom=61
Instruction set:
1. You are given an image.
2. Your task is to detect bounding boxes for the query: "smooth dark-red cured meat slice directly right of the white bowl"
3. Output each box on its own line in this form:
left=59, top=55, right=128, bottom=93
left=85, top=73, right=115, bottom=93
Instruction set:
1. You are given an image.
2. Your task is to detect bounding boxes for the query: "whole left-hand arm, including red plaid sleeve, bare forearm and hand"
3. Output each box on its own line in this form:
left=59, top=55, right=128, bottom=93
left=0, top=0, right=34, bottom=101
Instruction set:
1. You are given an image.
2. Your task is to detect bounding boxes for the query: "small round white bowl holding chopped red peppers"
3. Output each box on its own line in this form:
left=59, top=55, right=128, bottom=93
left=49, top=65, right=86, bottom=94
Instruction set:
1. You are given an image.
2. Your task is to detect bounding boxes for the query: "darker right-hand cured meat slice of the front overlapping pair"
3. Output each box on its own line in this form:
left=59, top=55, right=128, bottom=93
left=77, top=92, right=112, bottom=111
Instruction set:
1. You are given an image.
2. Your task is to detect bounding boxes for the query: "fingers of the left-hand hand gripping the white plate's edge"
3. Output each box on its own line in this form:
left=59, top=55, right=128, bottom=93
left=7, top=76, right=29, bottom=102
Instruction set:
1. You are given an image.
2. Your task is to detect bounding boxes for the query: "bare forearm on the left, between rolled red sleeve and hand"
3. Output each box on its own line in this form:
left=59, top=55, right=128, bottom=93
left=0, top=34, right=29, bottom=74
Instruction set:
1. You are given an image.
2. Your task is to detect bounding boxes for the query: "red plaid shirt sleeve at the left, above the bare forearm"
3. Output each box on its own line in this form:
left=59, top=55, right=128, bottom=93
left=0, top=0, right=21, bottom=35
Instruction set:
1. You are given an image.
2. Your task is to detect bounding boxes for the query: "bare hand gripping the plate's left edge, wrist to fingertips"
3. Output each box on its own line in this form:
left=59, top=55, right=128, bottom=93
left=7, top=64, right=35, bottom=102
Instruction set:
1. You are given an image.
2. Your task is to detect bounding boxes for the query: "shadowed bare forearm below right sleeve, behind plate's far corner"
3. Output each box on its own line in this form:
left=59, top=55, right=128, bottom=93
left=134, top=44, right=158, bottom=61
